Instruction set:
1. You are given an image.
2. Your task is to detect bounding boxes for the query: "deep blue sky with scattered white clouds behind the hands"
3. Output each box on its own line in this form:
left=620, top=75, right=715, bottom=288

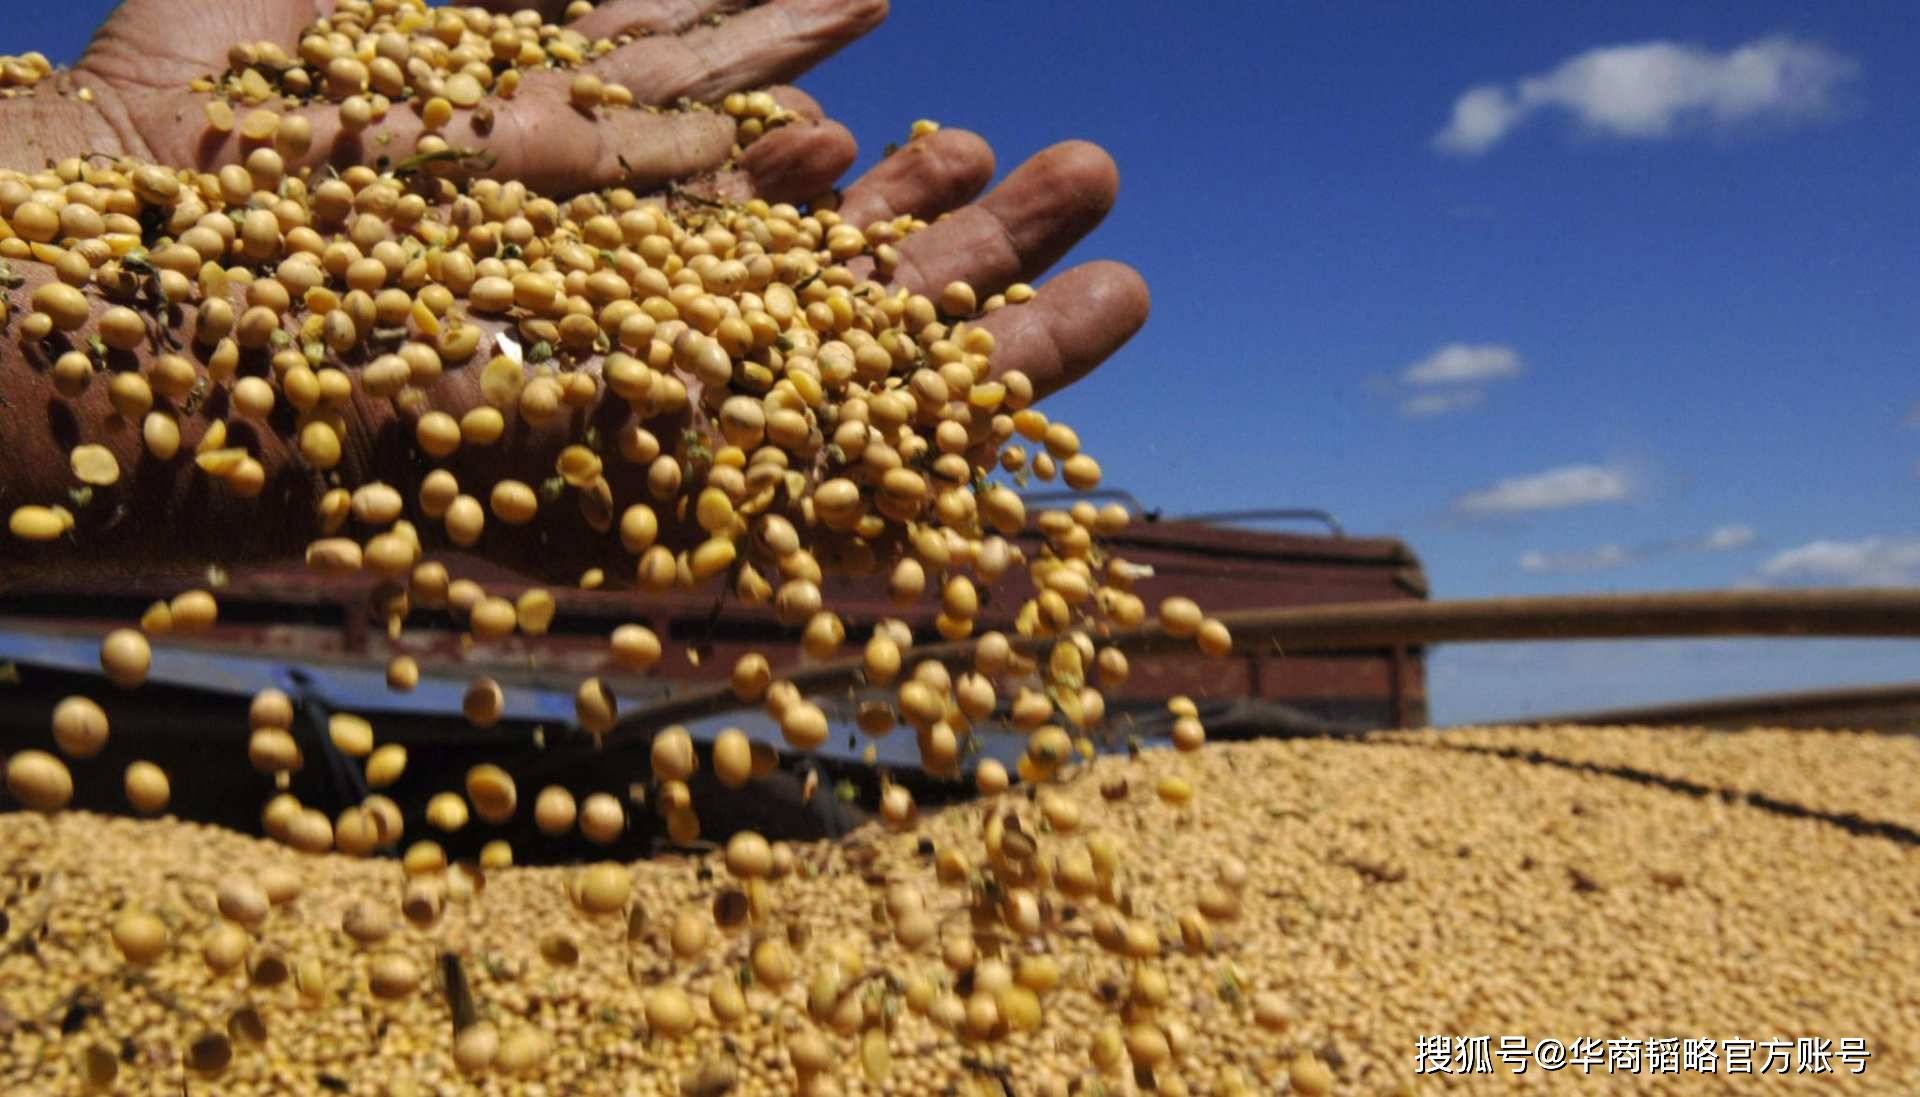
left=18, top=0, right=1920, bottom=720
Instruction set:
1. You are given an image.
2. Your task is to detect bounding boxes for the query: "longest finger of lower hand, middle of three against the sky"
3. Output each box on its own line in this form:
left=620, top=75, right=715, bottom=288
left=893, top=140, right=1119, bottom=298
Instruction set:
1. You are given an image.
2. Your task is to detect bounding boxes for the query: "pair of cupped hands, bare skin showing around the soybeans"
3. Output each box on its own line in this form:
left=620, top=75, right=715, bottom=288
left=0, top=0, right=1148, bottom=584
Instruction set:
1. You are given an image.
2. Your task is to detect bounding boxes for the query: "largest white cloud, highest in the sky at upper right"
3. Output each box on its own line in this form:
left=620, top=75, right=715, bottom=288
left=1434, top=37, right=1859, bottom=156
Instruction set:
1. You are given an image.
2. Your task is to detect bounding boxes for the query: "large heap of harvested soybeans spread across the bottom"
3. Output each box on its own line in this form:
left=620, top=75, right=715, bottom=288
left=0, top=728, right=1920, bottom=1095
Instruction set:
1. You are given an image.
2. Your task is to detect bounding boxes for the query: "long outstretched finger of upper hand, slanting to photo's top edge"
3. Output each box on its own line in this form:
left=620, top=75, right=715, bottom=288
left=593, top=0, right=887, bottom=104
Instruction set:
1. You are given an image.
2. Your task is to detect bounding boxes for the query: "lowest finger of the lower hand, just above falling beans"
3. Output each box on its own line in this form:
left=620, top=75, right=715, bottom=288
left=977, top=259, right=1150, bottom=396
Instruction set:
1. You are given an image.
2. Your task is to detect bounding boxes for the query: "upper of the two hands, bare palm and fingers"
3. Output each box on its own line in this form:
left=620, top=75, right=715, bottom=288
left=58, top=0, right=887, bottom=202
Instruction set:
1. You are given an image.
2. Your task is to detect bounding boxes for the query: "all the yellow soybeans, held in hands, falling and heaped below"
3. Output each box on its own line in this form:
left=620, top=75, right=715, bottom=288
left=0, top=0, right=1920, bottom=1097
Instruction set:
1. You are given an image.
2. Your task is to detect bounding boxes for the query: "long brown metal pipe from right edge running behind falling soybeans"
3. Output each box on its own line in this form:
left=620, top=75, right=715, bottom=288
left=611, top=588, right=1920, bottom=736
